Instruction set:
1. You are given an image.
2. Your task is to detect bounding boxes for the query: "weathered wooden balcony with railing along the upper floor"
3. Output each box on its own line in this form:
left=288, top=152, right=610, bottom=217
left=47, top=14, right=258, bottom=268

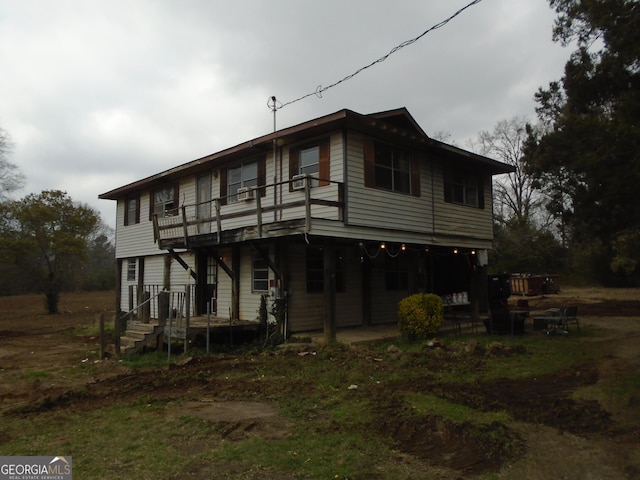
left=152, top=176, right=345, bottom=250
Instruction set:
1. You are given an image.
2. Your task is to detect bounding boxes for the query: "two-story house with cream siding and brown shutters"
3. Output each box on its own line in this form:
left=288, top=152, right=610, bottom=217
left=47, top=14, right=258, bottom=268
left=99, top=108, right=512, bottom=338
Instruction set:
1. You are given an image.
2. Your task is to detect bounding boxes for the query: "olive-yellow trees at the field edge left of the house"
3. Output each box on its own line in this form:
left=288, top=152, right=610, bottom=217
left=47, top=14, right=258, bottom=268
left=0, top=128, right=116, bottom=313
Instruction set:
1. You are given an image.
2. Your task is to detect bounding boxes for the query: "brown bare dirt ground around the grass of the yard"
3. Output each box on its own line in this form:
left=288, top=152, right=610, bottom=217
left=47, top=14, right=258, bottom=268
left=0, top=289, right=640, bottom=480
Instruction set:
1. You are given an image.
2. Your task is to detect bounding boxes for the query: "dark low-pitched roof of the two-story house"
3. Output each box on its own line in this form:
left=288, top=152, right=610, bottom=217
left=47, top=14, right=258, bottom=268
left=98, top=107, right=514, bottom=200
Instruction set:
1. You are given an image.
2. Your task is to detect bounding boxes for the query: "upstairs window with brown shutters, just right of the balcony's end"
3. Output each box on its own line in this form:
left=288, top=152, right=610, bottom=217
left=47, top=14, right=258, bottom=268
left=364, top=140, right=420, bottom=197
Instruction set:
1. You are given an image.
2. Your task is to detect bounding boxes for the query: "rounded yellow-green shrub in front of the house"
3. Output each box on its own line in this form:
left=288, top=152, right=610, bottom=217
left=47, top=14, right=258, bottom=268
left=398, top=293, right=444, bottom=339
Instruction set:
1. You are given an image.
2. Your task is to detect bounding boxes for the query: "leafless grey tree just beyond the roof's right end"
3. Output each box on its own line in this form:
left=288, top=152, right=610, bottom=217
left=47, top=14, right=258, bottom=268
left=471, top=117, right=542, bottom=223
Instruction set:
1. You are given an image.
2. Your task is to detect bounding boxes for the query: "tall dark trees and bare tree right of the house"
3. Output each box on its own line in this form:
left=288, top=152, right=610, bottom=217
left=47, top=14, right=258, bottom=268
left=475, top=0, right=640, bottom=286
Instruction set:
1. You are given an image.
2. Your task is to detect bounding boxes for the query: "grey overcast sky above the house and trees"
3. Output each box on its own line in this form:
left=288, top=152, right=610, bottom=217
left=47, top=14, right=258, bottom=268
left=0, top=0, right=570, bottom=226
